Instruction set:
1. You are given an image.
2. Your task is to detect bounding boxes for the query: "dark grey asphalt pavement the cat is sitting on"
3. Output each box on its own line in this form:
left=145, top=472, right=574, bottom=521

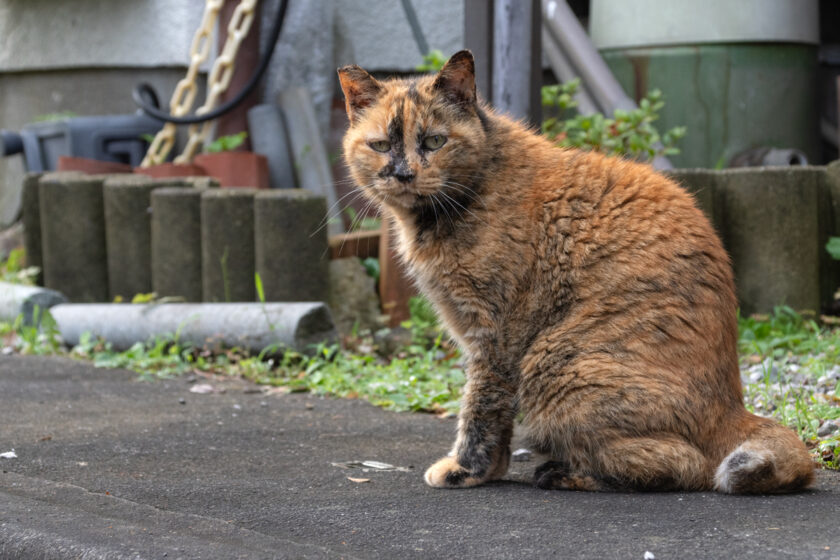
left=0, top=356, right=840, bottom=560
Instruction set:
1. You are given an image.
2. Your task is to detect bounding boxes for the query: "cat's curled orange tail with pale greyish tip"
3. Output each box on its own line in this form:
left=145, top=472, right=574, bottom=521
left=714, top=411, right=814, bottom=494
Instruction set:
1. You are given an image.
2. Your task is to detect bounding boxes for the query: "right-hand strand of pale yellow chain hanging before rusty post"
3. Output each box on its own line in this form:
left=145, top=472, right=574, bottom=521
left=175, top=0, right=258, bottom=163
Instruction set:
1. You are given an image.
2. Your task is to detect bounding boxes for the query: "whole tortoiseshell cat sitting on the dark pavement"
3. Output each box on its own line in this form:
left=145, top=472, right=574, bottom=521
left=338, top=51, right=814, bottom=493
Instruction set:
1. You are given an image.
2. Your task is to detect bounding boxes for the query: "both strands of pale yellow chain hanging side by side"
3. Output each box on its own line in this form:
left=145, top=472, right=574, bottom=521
left=140, top=0, right=258, bottom=167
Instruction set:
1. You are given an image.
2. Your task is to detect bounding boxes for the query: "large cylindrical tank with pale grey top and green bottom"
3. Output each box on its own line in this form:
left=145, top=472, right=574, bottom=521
left=590, top=0, right=820, bottom=167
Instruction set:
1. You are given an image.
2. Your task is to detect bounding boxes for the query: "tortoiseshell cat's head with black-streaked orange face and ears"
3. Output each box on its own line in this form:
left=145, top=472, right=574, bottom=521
left=338, top=51, right=487, bottom=209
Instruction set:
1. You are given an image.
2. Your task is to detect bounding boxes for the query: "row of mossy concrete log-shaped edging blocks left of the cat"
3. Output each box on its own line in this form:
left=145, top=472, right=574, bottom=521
left=23, top=172, right=329, bottom=302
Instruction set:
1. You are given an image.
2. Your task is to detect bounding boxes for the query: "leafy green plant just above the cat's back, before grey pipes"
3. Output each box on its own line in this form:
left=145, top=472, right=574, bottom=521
left=542, top=78, right=686, bottom=160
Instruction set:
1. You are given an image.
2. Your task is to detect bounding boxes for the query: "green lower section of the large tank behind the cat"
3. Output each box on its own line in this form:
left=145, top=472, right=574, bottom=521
left=601, top=44, right=819, bottom=167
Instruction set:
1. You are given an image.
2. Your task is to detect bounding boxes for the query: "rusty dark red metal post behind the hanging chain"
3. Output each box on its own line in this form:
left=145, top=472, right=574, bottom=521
left=216, top=0, right=260, bottom=152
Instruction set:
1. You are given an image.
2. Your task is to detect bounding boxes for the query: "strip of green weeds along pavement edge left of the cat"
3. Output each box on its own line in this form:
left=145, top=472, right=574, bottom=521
left=58, top=300, right=465, bottom=414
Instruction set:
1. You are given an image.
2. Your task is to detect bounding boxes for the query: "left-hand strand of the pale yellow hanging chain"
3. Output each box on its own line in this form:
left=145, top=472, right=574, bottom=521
left=140, top=0, right=224, bottom=167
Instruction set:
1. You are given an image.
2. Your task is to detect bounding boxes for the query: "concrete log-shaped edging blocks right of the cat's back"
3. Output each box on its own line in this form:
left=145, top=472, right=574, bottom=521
left=670, top=161, right=840, bottom=316
